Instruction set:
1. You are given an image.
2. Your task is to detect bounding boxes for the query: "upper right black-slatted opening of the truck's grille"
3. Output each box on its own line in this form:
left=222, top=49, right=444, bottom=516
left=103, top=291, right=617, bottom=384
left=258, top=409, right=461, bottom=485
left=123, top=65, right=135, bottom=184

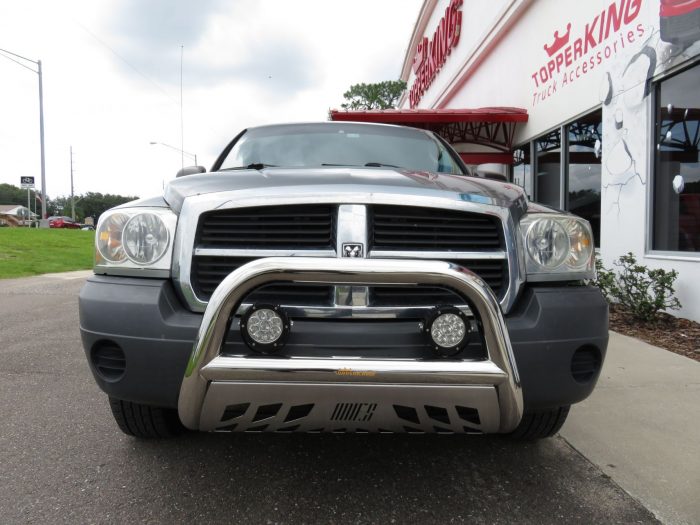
left=369, top=205, right=504, bottom=251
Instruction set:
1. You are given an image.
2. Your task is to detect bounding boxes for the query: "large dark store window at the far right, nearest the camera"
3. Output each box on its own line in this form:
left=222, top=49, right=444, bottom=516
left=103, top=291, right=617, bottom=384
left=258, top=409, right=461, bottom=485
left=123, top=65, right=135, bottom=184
left=652, top=64, right=700, bottom=252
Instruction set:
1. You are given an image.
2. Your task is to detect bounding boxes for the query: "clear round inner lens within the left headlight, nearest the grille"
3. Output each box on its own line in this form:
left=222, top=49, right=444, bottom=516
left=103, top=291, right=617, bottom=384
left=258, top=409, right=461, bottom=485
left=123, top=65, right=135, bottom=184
left=122, top=213, right=170, bottom=264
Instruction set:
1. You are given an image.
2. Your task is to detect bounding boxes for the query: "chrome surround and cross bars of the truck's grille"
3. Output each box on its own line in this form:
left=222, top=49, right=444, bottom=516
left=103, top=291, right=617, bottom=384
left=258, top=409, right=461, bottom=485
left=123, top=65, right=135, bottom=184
left=172, top=190, right=525, bottom=313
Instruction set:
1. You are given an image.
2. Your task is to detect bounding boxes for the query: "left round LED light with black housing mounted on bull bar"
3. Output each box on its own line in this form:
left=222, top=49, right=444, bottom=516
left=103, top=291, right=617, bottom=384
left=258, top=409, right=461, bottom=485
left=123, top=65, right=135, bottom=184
left=241, top=304, right=289, bottom=354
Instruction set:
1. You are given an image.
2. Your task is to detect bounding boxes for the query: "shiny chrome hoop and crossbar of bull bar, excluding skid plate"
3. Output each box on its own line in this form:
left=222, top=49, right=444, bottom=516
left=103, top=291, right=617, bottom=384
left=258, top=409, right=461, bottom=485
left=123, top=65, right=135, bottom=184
left=178, top=257, right=523, bottom=432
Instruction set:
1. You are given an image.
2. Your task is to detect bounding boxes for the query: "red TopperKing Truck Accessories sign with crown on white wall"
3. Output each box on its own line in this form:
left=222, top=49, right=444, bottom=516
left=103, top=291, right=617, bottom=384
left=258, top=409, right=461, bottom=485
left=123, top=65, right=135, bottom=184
left=530, top=0, right=646, bottom=106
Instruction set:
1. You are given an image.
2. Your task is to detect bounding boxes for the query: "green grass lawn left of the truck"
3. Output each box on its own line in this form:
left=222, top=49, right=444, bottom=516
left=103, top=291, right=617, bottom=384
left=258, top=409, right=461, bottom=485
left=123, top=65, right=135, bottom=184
left=0, top=228, right=95, bottom=279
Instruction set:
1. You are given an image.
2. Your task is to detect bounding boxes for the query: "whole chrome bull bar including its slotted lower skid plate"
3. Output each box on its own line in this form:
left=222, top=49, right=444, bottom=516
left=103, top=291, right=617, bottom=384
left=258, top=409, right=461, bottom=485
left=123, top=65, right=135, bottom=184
left=178, top=257, right=523, bottom=433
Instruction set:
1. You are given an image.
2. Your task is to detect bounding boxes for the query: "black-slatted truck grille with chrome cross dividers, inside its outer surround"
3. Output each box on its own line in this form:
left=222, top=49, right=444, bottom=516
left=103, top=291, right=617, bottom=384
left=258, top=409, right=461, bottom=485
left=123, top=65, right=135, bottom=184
left=184, top=200, right=510, bottom=316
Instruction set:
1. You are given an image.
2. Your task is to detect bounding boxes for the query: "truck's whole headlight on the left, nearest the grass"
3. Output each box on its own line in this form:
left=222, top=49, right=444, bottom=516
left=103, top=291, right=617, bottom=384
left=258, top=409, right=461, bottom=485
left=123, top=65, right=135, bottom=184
left=95, top=208, right=177, bottom=276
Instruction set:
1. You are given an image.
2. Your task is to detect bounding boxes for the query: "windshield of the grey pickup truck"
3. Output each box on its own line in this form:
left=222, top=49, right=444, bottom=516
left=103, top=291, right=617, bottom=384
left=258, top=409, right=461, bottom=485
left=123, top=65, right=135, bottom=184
left=219, top=123, right=463, bottom=174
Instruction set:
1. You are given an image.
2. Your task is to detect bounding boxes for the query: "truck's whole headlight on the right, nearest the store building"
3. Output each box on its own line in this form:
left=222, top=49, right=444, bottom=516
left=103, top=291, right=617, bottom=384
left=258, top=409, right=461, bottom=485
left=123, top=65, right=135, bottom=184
left=520, top=213, right=595, bottom=281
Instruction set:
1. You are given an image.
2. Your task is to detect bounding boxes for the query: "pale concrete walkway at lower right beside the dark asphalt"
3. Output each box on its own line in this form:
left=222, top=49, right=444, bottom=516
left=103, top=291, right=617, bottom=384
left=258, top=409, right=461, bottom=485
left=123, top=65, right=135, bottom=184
left=561, top=332, right=700, bottom=524
